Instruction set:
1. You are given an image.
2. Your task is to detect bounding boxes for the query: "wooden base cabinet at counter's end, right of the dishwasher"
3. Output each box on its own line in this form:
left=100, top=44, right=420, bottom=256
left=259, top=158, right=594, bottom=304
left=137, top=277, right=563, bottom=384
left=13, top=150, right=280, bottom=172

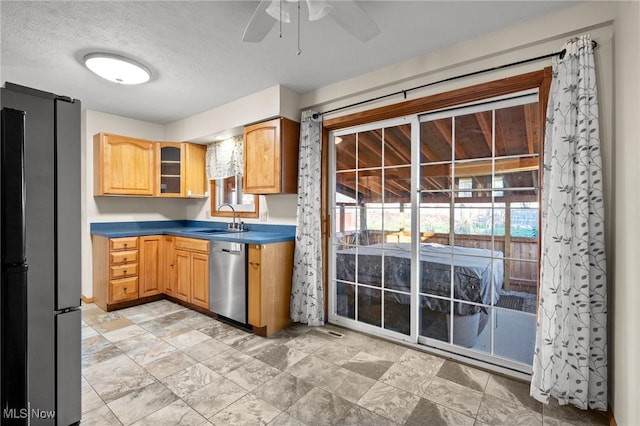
left=247, top=241, right=294, bottom=336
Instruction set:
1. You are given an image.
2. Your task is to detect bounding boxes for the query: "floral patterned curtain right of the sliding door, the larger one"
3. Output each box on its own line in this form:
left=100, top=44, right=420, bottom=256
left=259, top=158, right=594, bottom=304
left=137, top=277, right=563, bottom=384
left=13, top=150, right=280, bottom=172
left=531, top=35, right=607, bottom=410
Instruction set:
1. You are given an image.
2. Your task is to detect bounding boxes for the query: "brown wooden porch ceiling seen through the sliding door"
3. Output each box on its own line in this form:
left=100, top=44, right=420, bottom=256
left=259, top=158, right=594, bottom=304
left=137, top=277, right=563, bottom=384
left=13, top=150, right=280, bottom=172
left=336, top=103, right=540, bottom=203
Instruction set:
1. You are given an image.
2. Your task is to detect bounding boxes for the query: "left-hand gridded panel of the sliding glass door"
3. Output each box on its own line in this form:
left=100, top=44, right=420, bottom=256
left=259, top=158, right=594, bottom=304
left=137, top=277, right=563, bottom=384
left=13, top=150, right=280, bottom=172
left=332, top=120, right=412, bottom=335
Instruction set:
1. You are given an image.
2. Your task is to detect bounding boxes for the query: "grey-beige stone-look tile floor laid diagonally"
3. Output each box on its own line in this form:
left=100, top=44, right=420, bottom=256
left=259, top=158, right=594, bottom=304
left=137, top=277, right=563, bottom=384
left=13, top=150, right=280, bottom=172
left=82, top=300, right=607, bottom=426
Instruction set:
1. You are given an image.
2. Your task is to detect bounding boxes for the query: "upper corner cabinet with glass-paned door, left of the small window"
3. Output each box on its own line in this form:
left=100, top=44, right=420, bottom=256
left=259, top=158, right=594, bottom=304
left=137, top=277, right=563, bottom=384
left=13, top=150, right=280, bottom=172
left=156, top=142, right=208, bottom=198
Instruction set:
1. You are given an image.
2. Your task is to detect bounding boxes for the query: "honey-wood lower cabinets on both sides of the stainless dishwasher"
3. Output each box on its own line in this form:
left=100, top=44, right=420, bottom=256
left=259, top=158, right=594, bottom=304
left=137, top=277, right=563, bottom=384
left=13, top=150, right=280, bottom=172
left=92, top=231, right=294, bottom=336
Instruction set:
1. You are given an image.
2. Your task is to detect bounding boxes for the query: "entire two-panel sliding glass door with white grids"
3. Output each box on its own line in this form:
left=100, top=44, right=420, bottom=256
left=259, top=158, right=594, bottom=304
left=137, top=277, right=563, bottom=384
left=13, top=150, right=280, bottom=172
left=329, top=93, right=542, bottom=372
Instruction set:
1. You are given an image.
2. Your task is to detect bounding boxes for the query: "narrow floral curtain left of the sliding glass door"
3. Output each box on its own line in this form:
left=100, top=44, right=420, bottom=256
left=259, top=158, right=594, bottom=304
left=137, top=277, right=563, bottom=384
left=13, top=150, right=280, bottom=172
left=291, top=111, right=324, bottom=325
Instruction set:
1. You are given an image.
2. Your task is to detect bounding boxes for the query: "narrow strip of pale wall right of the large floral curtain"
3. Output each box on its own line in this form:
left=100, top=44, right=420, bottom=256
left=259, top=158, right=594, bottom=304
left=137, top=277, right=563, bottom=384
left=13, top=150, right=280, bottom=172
left=609, top=1, right=640, bottom=426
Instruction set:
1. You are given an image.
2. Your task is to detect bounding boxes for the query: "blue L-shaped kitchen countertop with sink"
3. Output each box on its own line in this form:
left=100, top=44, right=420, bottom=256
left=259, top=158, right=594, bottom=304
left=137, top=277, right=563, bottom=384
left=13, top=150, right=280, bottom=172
left=91, top=220, right=296, bottom=244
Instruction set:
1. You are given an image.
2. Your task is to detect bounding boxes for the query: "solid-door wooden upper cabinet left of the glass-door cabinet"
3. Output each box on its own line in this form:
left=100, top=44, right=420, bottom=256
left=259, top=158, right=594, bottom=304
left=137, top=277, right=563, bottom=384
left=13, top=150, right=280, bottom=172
left=93, top=133, right=155, bottom=196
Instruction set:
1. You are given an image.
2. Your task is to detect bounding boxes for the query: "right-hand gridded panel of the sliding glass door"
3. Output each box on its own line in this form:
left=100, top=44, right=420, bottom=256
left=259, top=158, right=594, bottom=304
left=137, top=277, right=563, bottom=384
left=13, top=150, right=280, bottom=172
left=418, top=94, right=540, bottom=365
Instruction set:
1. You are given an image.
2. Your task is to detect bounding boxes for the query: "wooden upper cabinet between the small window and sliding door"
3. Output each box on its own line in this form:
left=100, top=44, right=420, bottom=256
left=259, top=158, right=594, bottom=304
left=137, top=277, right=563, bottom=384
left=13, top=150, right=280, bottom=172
left=242, top=118, right=300, bottom=194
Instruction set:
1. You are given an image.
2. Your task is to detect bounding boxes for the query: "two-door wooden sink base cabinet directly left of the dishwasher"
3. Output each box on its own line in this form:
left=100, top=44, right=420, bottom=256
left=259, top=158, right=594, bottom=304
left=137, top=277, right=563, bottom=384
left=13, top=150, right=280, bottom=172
left=174, top=237, right=209, bottom=309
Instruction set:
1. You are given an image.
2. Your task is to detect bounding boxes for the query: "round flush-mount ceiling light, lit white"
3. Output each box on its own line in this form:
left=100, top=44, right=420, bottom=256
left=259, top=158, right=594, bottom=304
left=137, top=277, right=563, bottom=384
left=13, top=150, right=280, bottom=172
left=83, top=53, right=151, bottom=84
